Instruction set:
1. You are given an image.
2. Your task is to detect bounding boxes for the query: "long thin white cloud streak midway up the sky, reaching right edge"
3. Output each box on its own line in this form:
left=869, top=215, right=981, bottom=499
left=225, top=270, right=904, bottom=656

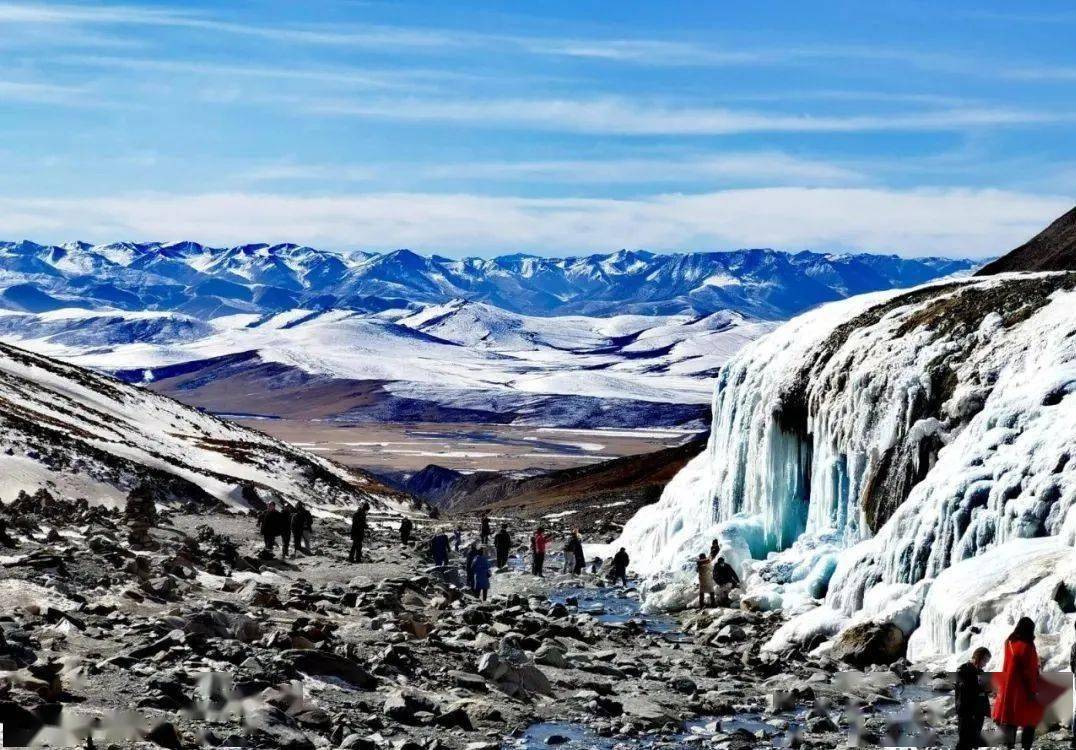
left=309, top=98, right=1076, bottom=136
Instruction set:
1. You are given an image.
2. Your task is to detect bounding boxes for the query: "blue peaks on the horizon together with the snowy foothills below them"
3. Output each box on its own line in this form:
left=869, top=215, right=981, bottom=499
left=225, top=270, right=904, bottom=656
left=0, top=242, right=973, bottom=427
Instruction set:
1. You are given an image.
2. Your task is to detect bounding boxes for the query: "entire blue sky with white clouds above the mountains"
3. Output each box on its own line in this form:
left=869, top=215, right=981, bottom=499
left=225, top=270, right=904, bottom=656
left=0, top=0, right=1076, bottom=256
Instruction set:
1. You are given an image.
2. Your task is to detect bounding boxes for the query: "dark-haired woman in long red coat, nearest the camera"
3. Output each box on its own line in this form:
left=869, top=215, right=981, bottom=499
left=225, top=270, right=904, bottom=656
left=993, top=618, right=1044, bottom=748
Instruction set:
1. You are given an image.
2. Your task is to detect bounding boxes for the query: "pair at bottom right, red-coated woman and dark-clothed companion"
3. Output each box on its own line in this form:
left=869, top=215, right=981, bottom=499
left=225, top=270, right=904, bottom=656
left=954, top=618, right=1076, bottom=750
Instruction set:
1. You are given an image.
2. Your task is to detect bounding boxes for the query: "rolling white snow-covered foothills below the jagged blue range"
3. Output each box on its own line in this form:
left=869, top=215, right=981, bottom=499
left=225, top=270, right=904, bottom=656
left=0, top=300, right=773, bottom=424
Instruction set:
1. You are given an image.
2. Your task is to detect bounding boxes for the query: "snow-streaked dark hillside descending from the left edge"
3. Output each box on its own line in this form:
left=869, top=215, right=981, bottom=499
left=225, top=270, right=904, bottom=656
left=0, top=343, right=399, bottom=508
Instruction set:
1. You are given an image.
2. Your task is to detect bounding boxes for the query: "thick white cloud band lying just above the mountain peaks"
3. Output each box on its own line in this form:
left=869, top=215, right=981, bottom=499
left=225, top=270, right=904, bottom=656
left=0, top=187, right=1072, bottom=256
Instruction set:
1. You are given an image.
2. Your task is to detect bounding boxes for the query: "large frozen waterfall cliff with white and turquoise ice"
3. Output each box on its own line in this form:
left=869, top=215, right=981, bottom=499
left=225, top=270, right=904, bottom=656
left=621, top=272, right=1076, bottom=661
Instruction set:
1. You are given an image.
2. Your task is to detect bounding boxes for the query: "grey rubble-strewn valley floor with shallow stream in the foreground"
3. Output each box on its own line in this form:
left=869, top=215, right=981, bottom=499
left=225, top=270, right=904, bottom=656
left=0, top=488, right=1067, bottom=750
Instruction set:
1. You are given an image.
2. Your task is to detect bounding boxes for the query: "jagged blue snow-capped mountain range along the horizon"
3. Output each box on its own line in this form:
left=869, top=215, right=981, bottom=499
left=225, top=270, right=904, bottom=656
left=0, top=241, right=975, bottom=320
